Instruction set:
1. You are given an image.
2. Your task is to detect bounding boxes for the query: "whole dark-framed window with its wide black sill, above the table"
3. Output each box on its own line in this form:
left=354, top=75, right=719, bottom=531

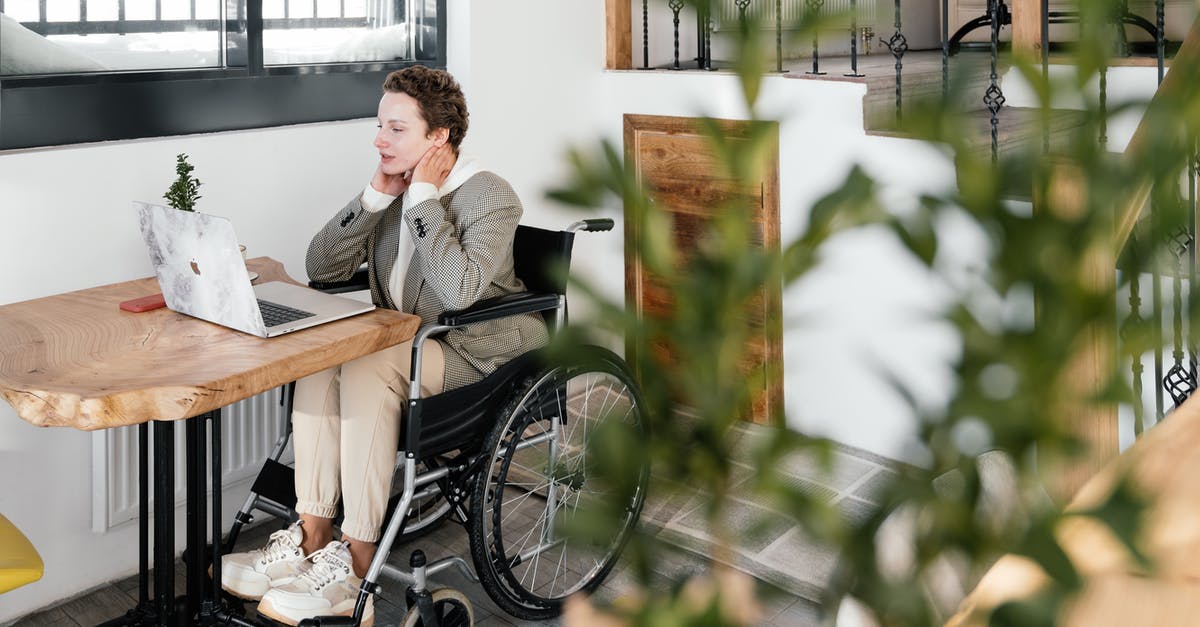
left=0, top=0, right=446, bottom=149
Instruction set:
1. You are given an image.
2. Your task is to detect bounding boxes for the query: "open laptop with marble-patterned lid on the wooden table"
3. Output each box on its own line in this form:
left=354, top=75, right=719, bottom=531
left=133, top=202, right=374, bottom=338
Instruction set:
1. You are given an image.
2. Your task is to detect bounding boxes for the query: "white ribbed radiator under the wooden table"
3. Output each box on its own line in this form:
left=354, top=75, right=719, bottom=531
left=91, top=388, right=290, bottom=533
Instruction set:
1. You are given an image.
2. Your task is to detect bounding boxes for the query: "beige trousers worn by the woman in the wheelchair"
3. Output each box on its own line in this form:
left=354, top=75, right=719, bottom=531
left=292, top=340, right=445, bottom=542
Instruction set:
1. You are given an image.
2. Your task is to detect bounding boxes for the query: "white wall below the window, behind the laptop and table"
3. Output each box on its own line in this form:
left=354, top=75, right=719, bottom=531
left=0, top=120, right=384, bottom=623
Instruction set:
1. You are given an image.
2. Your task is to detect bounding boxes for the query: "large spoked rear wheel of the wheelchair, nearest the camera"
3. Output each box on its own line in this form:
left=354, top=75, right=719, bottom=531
left=470, top=347, right=648, bottom=620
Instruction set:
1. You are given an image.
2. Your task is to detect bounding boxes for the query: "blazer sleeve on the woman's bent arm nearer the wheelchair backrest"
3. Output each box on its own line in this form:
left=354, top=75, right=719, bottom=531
left=404, top=173, right=522, bottom=310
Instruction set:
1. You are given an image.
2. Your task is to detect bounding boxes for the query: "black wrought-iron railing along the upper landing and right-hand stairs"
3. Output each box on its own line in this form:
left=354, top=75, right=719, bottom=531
left=641, top=0, right=1200, bottom=446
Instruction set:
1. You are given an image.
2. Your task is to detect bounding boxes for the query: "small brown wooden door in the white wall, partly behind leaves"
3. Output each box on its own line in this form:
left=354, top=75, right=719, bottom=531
left=624, top=114, right=784, bottom=424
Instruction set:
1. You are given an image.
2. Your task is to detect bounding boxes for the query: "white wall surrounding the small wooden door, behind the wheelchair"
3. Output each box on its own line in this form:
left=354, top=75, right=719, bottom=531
left=451, top=0, right=956, bottom=458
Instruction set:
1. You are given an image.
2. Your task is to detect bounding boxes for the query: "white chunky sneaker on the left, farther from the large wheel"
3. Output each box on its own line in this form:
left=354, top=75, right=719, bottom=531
left=221, top=521, right=308, bottom=601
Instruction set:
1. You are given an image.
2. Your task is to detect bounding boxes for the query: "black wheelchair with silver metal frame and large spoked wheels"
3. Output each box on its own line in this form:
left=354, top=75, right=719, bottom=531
left=222, top=219, right=649, bottom=627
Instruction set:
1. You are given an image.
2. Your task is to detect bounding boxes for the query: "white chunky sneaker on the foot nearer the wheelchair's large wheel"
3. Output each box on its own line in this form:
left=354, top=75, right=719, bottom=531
left=258, top=541, right=374, bottom=627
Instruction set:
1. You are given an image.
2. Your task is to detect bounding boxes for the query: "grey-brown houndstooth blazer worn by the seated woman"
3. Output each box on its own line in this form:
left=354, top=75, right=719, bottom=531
left=305, top=172, right=547, bottom=389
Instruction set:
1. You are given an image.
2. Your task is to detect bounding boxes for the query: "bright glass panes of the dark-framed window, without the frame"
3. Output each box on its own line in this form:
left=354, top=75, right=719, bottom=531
left=0, top=0, right=437, bottom=76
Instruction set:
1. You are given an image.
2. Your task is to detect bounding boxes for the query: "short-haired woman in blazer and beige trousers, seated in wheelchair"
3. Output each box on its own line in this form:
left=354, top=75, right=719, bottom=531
left=222, top=66, right=546, bottom=625
